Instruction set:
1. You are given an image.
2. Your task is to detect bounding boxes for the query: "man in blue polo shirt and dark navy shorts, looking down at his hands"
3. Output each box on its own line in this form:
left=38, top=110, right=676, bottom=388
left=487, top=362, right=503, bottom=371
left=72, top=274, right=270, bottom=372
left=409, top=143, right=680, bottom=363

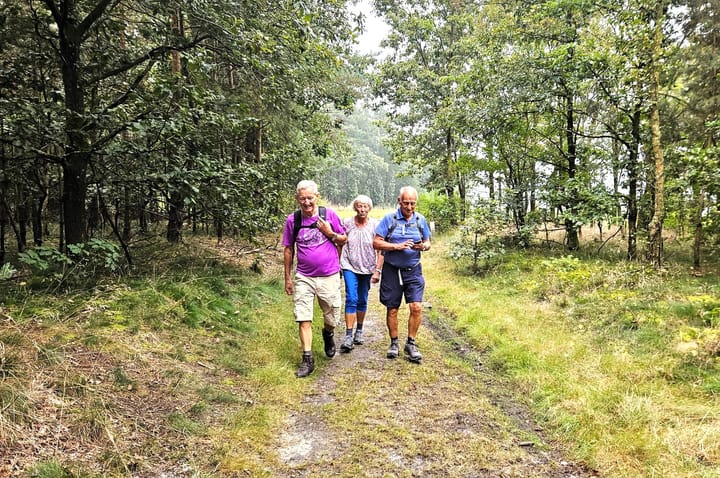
left=373, top=186, right=430, bottom=363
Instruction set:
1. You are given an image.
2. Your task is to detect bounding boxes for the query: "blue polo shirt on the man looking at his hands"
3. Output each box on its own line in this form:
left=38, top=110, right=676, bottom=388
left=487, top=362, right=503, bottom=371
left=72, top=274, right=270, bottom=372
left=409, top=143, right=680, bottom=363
left=375, top=208, right=430, bottom=269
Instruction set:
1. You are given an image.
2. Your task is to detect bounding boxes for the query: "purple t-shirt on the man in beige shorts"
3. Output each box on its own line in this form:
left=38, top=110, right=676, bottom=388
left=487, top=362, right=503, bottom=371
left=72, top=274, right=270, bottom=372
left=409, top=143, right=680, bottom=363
left=283, top=208, right=345, bottom=277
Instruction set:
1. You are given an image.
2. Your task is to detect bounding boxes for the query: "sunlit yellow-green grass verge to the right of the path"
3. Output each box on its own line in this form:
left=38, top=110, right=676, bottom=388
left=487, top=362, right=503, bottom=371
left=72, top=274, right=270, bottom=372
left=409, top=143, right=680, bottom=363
left=424, top=236, right=720, bottom=478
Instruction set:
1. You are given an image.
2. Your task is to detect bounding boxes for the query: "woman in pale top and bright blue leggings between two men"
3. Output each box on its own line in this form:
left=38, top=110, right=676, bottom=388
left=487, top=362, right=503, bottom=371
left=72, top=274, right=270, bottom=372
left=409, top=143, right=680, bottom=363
left=340, top=194, right=383, bottom=353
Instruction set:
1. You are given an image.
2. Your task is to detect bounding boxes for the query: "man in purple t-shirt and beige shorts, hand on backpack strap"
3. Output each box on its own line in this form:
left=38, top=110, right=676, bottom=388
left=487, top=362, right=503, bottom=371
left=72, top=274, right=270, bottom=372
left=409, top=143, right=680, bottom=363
left=283, top=180, right=347, bottom=377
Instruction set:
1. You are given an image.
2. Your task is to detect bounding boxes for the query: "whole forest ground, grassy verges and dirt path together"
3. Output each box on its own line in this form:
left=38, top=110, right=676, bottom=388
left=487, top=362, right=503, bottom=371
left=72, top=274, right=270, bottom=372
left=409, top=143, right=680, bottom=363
left=0, top=230, right=720, bottom=478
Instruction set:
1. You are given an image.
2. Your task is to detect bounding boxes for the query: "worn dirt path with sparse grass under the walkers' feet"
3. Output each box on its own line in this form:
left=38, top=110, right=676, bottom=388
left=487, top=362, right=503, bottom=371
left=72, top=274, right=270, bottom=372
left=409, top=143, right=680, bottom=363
left=272, top=304, right=597, bottom=478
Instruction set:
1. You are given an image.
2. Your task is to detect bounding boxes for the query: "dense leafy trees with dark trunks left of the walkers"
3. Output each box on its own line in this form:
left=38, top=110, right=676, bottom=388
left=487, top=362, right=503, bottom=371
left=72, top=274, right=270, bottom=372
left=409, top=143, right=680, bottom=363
left=0, top=0, right=363, bottom=247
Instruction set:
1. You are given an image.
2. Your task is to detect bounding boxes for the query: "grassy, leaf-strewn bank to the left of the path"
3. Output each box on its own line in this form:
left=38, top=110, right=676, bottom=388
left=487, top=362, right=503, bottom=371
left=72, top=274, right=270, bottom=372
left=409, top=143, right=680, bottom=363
left=0, top=239, right=306, bottom=477
